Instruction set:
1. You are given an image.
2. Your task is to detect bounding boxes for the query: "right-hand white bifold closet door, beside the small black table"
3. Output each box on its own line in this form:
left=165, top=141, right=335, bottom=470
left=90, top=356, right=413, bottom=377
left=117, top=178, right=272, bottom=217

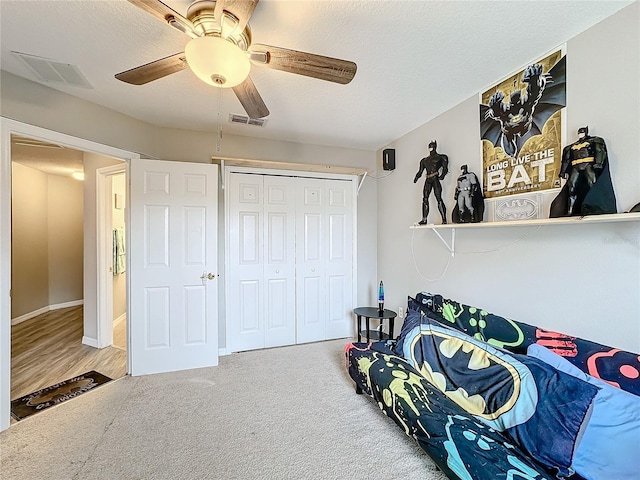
left=296, top=179, right=354, bottom=343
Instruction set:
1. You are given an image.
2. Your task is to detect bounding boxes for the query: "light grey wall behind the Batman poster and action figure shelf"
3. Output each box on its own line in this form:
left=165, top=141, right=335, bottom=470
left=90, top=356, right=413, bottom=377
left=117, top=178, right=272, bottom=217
left=378, top=2, right=640, bottom=352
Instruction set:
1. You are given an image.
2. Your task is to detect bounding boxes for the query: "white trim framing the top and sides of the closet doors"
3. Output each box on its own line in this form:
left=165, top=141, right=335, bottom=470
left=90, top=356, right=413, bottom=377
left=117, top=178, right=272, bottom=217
left=219, top=164, right=358, bottom=355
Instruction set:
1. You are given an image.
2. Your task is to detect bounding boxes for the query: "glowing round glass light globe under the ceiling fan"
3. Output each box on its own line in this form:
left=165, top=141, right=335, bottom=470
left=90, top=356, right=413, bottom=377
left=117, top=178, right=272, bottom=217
left=184, top=36, right=251, bottom=88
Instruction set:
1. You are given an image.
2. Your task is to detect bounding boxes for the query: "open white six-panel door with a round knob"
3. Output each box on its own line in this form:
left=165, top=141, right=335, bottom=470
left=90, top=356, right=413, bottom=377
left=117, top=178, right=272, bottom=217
left=128, top=160, right=218, bottom=375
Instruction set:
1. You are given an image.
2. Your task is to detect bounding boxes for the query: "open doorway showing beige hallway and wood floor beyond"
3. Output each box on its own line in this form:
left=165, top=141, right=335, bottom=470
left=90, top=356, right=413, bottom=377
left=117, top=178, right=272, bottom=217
left=11, top=135, right=127, bottom=412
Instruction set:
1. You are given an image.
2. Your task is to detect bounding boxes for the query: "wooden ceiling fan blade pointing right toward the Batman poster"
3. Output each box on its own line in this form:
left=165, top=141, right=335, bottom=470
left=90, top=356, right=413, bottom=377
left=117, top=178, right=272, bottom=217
left=251, top=45, right=358, bottom=85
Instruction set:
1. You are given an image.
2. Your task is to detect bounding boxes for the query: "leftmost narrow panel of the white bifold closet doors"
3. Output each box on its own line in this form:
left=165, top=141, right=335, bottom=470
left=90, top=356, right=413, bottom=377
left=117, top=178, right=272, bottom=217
left=226, top=174, right=265, bottom=352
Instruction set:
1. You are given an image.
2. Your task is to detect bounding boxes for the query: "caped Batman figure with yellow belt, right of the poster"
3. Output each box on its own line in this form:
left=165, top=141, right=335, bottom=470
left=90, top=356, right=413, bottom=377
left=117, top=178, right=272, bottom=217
left=549, top=127, right=617, bottom=218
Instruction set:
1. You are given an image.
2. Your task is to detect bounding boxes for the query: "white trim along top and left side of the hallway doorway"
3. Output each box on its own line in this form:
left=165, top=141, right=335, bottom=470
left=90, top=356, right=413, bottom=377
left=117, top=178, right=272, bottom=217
left=0, top=117, right=140, bottom=431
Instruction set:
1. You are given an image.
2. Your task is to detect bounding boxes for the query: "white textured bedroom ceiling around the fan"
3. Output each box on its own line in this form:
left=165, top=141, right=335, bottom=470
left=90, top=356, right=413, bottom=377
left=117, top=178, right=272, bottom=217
left=0, top=0, right=637, bottom=150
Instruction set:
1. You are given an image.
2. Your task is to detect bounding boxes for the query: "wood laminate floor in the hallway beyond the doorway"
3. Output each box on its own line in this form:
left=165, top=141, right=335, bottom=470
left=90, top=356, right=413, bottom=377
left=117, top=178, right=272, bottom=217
left=11, top=306, right=127, bottom=400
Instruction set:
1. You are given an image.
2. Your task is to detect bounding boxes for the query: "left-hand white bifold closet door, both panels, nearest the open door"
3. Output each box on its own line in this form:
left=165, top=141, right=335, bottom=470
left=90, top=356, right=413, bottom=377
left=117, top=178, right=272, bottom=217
left=227, top=173, right=295, bottom=352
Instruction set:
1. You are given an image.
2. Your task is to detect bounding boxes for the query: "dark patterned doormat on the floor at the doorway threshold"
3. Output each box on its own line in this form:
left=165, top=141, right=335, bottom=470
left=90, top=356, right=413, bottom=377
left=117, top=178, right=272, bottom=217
left=11, top=370, right=112, bottom=421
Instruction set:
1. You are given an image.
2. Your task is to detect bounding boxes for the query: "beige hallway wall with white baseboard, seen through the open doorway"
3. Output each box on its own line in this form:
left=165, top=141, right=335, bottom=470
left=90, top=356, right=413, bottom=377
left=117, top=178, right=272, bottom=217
left=11, top=162, right=82, bottom=321
